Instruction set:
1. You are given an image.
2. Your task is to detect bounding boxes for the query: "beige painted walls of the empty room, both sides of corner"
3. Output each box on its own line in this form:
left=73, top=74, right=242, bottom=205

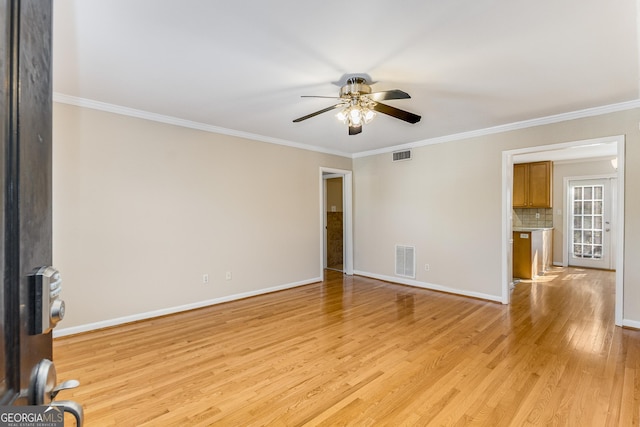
left=54, top=103, right=640, bottom=331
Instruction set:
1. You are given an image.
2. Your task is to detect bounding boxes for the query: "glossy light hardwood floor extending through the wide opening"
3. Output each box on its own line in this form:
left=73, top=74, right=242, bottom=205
left=54, top=268, right=640, bottom=427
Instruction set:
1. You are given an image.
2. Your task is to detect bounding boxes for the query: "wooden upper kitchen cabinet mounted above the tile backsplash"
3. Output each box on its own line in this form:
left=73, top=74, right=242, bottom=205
left=512, top=161, right=553, bottom=208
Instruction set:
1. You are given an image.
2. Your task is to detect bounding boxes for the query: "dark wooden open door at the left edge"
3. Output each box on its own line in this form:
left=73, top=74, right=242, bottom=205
left=0, top=0, right=52, bottom=405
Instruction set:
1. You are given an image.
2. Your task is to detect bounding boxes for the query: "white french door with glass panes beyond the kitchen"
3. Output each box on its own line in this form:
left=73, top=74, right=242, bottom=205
left=568, top=178, right=616, bottom=270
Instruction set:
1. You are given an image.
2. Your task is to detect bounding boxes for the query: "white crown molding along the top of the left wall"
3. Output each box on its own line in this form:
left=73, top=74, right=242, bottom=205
left=53, top=92, right=351, bottom=158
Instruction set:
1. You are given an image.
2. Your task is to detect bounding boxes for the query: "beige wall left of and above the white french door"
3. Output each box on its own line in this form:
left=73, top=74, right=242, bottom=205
left=553, top=159, right=616, bottom=265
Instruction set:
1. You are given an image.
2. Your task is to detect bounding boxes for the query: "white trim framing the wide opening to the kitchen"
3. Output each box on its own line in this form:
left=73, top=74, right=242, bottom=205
left=501, top=135, right=625, bottom=326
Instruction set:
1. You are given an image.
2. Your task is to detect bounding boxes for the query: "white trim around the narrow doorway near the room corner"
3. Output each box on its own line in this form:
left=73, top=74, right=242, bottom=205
left=319, top=167, right=353, bottom=277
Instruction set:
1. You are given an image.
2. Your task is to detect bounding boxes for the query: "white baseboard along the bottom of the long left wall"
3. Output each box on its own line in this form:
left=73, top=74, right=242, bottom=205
left=53, top=277, right=322, bottom=338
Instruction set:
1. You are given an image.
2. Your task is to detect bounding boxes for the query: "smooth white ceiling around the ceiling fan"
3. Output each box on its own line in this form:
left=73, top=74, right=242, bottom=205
left=53, top=0, right=640, bottom=154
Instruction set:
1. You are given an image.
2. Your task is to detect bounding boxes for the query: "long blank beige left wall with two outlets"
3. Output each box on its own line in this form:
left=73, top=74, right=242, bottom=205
left=53, top=103, right=351, bottom=333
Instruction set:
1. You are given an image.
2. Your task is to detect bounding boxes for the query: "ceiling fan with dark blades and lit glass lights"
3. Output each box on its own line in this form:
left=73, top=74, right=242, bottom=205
left=293, top=77, right=421, bottom=135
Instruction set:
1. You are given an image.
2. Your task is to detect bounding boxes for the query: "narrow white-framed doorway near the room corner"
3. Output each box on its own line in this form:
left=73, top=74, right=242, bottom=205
left=320, top=167, right=353, bottom=275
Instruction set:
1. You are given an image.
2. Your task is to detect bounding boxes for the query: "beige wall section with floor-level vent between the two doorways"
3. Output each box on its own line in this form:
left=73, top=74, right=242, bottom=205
left=354, top=135, right=502, bottom=298
